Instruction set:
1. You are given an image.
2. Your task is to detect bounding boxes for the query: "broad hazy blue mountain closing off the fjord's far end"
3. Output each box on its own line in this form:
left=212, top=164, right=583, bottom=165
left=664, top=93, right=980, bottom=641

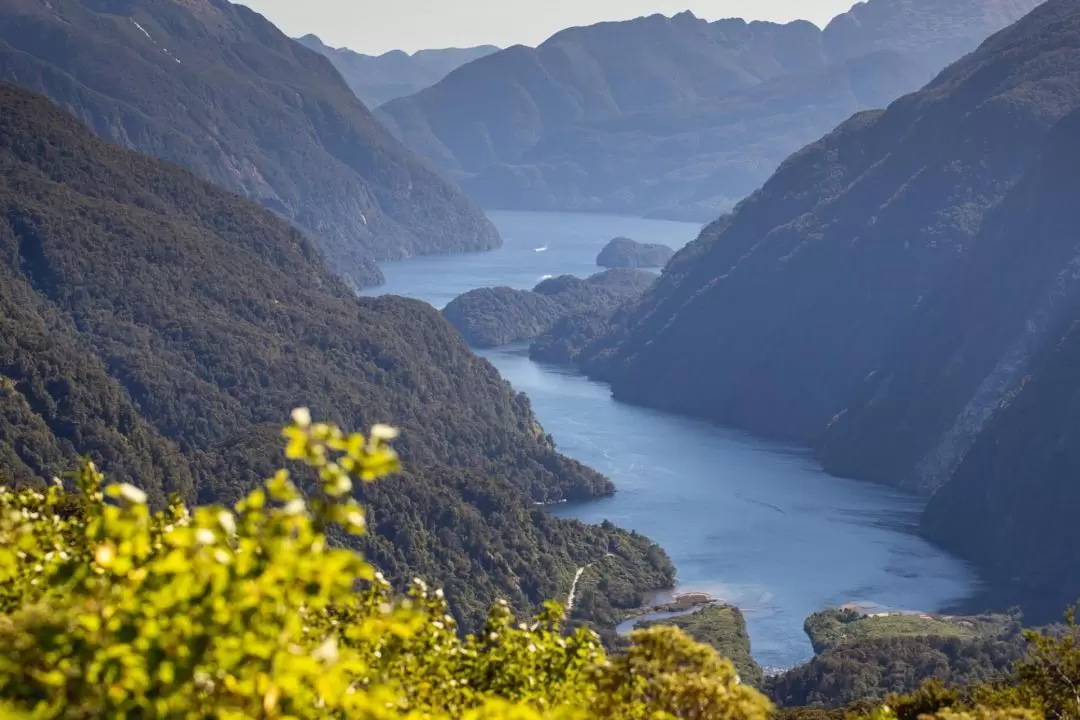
left=379, top=0, right=1040, bottom=220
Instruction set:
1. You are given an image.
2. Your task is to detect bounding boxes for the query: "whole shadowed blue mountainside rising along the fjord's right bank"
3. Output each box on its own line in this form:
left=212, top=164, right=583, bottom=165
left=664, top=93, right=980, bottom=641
left=570, top=0, right=1080, bottom=612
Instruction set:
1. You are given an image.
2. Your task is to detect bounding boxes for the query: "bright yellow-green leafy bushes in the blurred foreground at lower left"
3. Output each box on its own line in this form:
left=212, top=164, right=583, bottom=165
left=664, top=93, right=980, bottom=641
left=0, top=410, right=770, bottom=720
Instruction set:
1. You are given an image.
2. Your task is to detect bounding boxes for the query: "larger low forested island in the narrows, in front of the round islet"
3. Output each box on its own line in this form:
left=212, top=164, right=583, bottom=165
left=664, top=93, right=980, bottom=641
left=443, top=269, right=657, bottom=348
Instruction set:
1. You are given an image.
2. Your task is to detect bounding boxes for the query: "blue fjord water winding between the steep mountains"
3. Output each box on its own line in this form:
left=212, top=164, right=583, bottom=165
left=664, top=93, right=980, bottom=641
left=378, top=212, right=977, bottom=667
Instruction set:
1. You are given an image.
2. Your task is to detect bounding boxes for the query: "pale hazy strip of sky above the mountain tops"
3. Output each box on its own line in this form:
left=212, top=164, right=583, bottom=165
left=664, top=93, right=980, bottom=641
left=240, top=0, right=854, bottom=54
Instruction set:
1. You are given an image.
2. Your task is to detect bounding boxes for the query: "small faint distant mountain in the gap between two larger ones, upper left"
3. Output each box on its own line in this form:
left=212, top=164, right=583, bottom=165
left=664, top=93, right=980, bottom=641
left=297, top=35, right=499, bottom=108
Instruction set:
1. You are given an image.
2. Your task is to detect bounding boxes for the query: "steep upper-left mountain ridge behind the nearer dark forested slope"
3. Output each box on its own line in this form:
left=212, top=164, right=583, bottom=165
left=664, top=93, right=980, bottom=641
left=0, top=0, right=499, bottom=286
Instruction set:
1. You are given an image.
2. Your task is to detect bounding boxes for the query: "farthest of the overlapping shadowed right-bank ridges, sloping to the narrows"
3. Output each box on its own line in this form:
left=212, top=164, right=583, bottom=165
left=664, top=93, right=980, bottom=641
left=574, top=2, right=1080, bottom=440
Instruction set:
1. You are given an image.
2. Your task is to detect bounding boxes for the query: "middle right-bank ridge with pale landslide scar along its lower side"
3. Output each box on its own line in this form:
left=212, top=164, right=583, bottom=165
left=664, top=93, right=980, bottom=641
left=820, top=102, right=1080, bottom=491
